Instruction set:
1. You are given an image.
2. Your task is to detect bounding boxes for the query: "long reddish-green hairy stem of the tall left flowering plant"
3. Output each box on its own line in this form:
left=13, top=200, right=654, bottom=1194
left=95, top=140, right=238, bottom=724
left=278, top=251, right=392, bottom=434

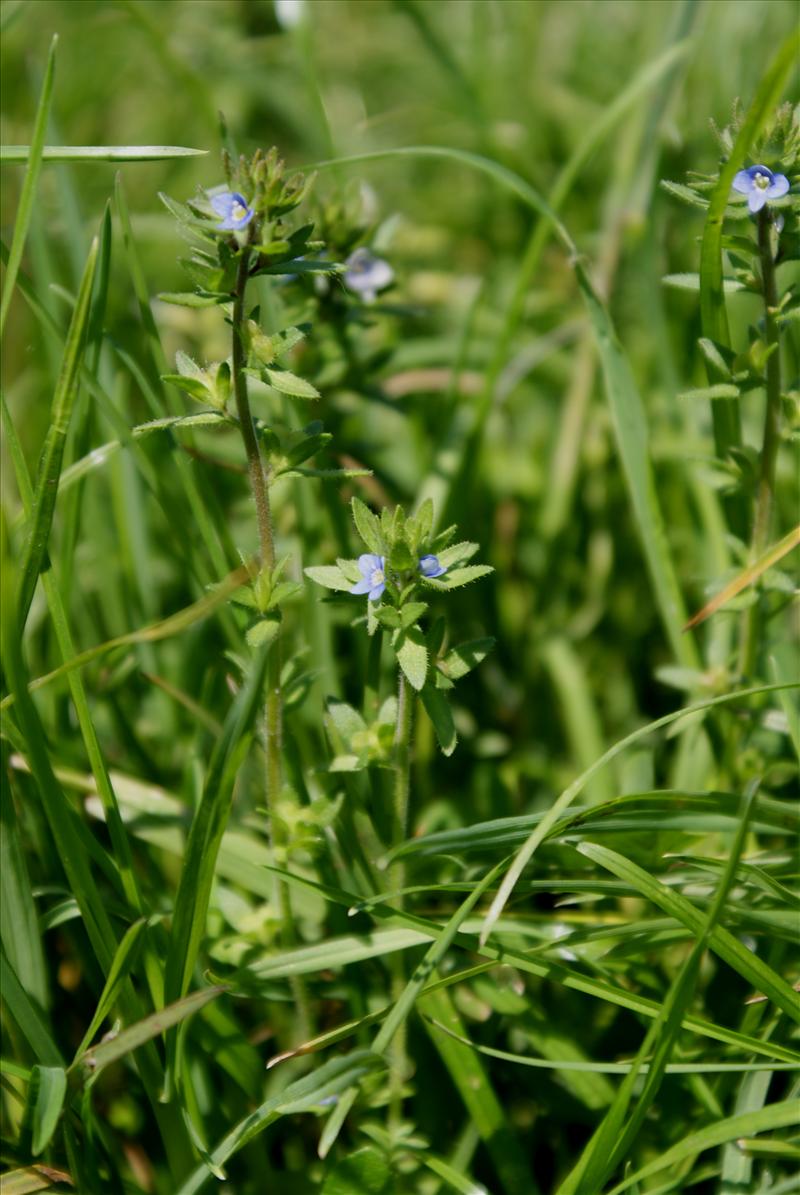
left=232, top=247, right=311, bottom=1044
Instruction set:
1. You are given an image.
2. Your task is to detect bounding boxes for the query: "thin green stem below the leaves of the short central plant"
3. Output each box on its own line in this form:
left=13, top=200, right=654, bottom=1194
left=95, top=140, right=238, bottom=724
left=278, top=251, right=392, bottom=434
left=389, top=673, right=414, bottom=1128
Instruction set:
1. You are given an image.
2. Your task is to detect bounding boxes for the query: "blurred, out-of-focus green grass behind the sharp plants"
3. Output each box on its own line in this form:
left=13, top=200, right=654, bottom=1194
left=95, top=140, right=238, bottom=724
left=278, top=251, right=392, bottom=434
left=0, top=0, right=798, bottom=1195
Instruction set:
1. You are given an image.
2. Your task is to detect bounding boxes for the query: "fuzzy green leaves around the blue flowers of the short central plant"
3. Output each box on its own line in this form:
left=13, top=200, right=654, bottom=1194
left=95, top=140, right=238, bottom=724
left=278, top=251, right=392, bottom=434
left=305, top=498, right=494, bottom=766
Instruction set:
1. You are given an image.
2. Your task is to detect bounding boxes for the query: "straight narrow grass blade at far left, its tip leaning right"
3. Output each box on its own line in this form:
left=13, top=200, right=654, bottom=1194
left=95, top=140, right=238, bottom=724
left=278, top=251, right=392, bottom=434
left=17, top=230, right=97, bottom=632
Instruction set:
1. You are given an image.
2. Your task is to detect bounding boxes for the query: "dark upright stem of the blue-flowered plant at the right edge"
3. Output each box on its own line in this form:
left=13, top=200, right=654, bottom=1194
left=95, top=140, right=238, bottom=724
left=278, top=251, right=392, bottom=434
left=739, top=206, right=781, bottom=676
